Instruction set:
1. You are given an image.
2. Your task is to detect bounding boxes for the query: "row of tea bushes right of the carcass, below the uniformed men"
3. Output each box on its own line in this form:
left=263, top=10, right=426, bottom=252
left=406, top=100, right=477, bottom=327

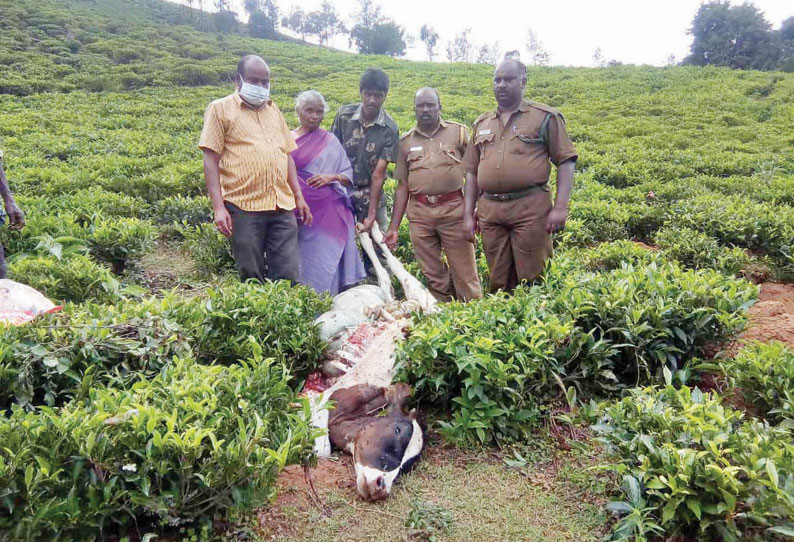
left=398, top=257, right=757, bottom=443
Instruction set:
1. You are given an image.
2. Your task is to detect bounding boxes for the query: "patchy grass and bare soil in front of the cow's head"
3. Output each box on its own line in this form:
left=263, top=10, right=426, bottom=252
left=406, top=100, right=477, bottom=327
left=256, top=442, right=606, bottom=542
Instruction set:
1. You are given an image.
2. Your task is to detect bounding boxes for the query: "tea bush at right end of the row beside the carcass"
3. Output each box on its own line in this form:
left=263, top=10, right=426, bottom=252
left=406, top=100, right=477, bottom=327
left=546, top=255, right=758, bottom=387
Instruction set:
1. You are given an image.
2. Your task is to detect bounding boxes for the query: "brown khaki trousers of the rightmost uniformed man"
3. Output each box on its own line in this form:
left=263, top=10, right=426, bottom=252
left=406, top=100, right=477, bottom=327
left=477, top=190, right=552, bottom=292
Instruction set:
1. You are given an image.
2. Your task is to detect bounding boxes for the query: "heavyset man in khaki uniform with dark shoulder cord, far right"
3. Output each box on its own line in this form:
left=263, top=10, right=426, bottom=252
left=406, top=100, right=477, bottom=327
left=463, top=59, right=577, bottom=291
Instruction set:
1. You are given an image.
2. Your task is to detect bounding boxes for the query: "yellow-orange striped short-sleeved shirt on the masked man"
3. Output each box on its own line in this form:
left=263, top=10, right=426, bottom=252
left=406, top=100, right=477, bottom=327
left=199, top=92, right=298, bottom=211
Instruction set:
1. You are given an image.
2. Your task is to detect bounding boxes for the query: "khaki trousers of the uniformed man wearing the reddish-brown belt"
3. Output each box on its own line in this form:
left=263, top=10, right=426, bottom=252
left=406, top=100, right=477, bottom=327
left=406, top=198, right=482, bottom=301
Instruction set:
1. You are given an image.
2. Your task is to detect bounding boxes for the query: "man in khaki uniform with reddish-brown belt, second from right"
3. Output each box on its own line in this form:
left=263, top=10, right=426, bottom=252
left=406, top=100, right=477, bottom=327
left=385, top=88, right=482, bottom=301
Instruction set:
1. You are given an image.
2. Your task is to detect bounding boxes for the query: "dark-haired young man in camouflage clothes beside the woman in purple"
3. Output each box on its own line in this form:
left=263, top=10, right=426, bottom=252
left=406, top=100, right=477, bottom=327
left=331, top=69, right=399, bottom=231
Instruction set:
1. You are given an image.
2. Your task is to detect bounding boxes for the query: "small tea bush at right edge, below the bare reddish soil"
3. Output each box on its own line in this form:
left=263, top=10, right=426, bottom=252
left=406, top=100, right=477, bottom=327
left=722, top=342, right=794, bottom=429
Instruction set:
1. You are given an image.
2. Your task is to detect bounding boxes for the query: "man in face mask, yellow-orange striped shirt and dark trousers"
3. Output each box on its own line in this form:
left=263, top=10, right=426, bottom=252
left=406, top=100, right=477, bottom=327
left=199, top=55, right=312, bottom=282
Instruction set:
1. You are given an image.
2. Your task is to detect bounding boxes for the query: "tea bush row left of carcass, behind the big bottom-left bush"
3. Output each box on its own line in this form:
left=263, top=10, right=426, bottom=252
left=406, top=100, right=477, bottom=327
left=0, top=281, right=329, bottom=408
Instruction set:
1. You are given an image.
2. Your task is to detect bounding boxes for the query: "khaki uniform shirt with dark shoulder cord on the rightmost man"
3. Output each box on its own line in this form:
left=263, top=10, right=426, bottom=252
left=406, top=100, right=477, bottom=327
left=463, top=100, right=578, bottom=193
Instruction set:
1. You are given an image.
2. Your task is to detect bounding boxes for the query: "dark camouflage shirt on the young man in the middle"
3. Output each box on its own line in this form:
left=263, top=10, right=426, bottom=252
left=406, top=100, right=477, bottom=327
left=331, top=104, right=399, bottom=187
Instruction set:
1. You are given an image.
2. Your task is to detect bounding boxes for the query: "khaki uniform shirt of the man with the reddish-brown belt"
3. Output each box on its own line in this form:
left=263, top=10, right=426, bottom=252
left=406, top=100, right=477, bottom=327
left=394, top=119, right=469, bottom=195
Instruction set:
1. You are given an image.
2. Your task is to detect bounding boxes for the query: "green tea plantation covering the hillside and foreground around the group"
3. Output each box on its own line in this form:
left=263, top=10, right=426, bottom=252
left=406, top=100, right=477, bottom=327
left=0, top=0, right=794, bottom=541
